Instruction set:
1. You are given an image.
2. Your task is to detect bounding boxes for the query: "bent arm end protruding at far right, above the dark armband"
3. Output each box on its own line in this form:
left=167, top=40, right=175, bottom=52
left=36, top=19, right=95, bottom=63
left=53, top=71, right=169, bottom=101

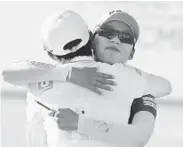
left=144, top=74, right=172, bottom=98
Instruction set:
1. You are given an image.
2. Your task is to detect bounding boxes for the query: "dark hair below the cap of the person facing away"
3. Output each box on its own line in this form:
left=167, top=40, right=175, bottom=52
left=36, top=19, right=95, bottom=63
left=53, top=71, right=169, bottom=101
left=48, top=31, right=92, bottom=63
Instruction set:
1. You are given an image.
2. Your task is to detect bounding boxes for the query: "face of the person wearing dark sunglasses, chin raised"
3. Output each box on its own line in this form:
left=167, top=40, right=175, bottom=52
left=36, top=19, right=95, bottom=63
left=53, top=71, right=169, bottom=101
left=94, top=21, right=134, bottom=64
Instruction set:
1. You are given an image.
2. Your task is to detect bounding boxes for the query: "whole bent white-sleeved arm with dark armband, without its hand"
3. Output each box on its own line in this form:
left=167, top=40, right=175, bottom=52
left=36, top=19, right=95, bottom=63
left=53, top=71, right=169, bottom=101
left=78, top=94, right=156, bottom=147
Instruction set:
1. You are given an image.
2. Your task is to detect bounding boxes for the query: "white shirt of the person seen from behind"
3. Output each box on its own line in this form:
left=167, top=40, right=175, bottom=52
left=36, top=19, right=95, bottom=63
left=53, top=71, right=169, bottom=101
left=30, top=57, right=146, bottom=147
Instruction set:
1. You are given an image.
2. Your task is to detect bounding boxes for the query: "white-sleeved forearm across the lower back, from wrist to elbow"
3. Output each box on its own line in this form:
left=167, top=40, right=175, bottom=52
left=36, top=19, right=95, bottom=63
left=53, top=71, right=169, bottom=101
left=78, top=115, right=153, bottom=147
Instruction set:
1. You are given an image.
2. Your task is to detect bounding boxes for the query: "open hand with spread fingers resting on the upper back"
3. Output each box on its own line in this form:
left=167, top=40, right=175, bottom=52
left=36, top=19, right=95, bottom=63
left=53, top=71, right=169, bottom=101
left=69, top=67, right=116, bottom=95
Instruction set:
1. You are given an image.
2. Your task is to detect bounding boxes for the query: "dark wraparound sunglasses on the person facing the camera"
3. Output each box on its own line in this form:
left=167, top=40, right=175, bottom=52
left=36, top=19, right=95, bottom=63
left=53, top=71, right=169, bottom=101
left=97, top=27, right=136, bottom=44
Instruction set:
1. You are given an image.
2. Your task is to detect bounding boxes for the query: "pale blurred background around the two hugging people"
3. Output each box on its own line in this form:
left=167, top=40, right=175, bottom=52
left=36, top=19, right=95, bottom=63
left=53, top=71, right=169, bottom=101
left=0, top=1, right=183, bottom=147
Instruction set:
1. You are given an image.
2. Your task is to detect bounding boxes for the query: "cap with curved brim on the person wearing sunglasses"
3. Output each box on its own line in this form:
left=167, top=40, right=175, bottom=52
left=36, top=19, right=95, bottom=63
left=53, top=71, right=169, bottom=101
left=95, top=10, right=139, bottom=41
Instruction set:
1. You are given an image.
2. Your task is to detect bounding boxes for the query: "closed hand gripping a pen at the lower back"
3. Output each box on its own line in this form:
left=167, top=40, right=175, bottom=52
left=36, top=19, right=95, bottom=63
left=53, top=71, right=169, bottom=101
left=55, top=108, right=79, bottom=131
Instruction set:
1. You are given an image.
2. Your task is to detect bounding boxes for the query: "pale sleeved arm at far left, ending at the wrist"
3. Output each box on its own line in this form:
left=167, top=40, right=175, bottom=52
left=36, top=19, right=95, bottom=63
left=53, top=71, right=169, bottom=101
left=2, top=61, right=69, bottom=85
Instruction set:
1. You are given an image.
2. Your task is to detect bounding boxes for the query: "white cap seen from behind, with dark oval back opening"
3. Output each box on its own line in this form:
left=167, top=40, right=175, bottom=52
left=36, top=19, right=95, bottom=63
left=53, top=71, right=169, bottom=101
left=41, top=10, right=90, bottom=56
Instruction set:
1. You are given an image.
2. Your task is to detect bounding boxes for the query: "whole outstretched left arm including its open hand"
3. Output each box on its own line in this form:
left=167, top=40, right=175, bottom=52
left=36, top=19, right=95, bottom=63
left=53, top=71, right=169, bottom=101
left=2, top=61, right=115, bottom=94
